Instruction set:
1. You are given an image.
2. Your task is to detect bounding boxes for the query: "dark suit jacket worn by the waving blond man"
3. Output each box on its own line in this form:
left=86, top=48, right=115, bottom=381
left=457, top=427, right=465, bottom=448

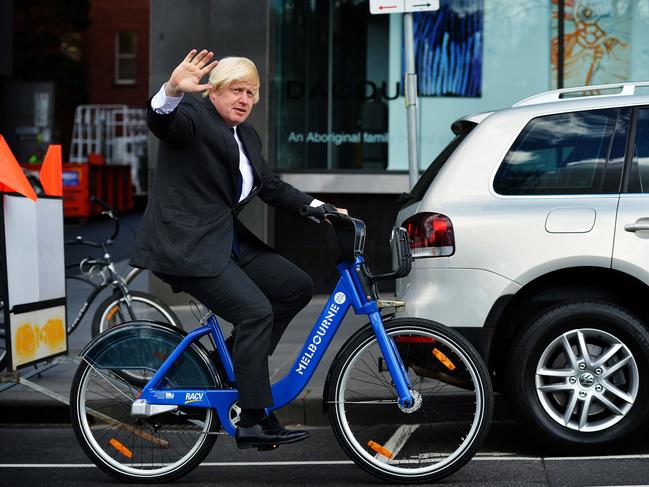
left=131, top=95, right=313, bottom=276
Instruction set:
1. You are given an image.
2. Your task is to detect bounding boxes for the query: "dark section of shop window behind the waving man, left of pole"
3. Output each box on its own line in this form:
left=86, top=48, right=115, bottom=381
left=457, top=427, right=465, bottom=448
left=271, top=0, right=388, bottom=171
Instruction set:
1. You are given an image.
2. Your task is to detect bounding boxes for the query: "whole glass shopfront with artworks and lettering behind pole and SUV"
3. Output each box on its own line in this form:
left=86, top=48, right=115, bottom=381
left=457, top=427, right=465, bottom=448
left=270, top=0, right=649, bottom=172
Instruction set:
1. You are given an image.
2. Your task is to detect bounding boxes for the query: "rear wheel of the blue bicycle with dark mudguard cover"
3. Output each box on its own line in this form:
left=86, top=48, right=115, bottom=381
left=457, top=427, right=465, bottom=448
left=70, top=323, right=221, bottom=483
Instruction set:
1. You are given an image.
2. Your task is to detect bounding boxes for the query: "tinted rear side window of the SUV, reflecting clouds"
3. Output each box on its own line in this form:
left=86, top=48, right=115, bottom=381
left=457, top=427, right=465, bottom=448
left=494, top=108, right=619, bottom=195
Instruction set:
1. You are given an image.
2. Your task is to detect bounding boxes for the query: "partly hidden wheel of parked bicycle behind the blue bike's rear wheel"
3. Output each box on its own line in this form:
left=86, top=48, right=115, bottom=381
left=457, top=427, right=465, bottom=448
left=91, top=291, right=183, bottom=338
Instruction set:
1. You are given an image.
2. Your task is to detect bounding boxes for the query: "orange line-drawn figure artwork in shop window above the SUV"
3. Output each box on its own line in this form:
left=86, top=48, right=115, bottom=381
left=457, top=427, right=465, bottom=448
left=551, top=0, right=632, bottom=88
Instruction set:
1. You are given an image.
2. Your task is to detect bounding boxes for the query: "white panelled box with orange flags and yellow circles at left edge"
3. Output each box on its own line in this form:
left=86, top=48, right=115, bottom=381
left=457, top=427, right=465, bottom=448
left=0, top=136, right=67, bottom=370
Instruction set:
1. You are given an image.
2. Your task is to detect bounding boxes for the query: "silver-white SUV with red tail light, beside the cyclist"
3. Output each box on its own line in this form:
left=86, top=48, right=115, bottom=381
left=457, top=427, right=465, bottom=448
left=397, top=83, right=649, bottom=447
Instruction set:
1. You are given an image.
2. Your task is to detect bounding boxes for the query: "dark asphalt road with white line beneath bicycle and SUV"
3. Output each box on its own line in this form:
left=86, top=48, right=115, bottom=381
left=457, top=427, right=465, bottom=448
left=0, top=422, right=649, bottom=487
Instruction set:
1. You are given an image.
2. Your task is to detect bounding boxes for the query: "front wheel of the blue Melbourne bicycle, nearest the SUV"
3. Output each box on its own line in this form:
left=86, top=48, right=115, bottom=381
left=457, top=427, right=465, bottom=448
left=327, top=318, right=493, bottom=483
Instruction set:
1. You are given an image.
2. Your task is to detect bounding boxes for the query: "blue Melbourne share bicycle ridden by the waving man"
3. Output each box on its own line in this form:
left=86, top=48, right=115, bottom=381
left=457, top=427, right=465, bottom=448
left=70, top=206, right=493, bottom=483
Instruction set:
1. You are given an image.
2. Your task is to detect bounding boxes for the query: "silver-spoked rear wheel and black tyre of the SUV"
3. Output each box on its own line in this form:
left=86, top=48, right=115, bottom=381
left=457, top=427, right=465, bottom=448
left=508, top=301, right=649, bottom=448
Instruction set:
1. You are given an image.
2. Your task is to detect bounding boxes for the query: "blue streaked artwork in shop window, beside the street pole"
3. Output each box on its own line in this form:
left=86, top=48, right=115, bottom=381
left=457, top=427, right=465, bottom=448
left=402, top=0, right=484, bottom=97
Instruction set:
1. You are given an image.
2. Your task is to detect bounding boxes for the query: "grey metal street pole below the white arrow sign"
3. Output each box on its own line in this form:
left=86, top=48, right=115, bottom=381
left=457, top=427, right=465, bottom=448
left=403, top=12, right=419, bottom=191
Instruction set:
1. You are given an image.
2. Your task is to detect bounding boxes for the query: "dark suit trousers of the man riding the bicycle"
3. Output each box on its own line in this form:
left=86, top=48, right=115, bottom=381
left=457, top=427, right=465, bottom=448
left=156, top=246, right=313, bottom=409
